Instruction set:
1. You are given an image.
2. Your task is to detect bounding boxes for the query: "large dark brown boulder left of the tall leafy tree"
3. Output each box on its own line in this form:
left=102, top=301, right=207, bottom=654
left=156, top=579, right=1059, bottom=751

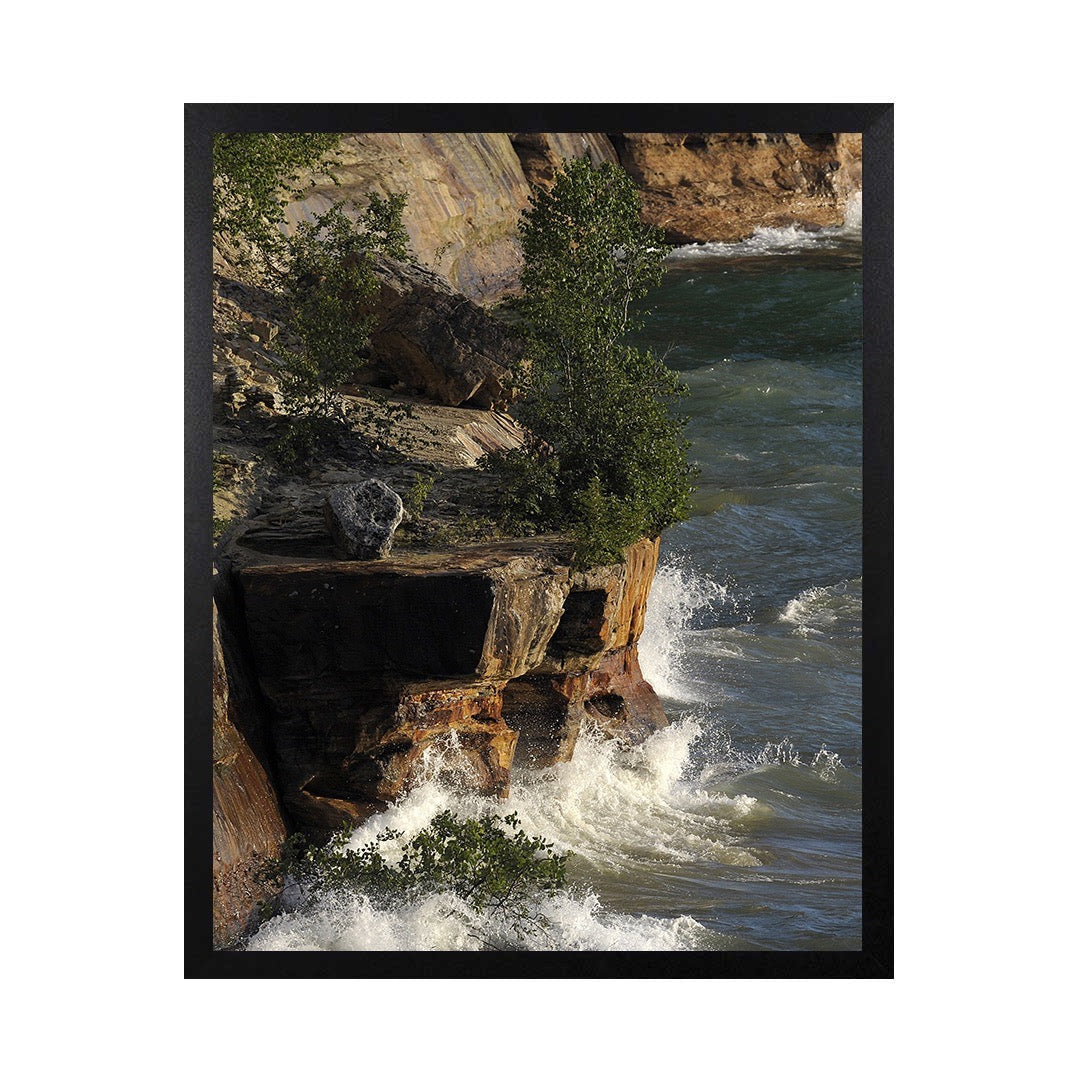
left=372, top=258, right=523, bottom=408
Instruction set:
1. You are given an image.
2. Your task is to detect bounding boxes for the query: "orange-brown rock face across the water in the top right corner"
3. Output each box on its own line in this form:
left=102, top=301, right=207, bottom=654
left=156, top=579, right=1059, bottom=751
left=612, top=132, right=862, bottom=244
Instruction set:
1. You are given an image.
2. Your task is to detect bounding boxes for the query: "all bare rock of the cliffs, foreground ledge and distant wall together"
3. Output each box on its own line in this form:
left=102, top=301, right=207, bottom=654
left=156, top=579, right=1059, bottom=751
left=206, top=133, right=861, bottom=946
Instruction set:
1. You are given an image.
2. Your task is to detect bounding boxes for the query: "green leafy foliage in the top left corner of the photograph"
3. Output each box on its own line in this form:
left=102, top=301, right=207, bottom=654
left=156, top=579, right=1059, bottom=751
left=213, top=132, right=341, bottom=271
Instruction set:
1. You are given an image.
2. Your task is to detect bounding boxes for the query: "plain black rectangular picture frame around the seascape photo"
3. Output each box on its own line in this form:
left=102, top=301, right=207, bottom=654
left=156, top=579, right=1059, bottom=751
left=184, top=104, right=893, bottom=978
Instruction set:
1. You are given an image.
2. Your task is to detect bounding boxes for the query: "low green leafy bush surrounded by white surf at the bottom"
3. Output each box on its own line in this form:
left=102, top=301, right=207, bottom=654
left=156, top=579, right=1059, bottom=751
left=262, top=810, right=570, bottom=939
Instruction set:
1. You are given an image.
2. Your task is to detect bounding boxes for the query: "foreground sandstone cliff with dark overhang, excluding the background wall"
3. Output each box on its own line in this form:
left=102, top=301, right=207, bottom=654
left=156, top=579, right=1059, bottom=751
left=214, top=254, right=666, bottom=947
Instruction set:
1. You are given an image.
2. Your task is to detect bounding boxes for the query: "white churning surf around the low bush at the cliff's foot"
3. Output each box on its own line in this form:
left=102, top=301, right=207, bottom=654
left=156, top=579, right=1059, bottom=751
left=248, top=720, right=760, bottom=950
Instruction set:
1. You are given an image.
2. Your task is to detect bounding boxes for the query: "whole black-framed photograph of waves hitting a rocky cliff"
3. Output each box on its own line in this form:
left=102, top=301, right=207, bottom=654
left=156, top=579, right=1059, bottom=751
left=186, top=104, right=892, bottom=978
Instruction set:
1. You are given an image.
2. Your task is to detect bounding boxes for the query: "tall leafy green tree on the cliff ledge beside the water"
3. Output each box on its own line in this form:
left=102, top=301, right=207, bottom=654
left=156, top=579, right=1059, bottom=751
left=488, top=159, right=693, bottom=565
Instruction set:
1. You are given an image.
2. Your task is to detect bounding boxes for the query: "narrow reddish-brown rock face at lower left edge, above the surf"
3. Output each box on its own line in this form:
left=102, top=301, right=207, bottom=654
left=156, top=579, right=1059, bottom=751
left=213, top=605, right=285, bottom=948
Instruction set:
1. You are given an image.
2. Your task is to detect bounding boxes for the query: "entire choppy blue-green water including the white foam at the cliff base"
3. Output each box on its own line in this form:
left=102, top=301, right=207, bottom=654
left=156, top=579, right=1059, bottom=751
left=251, top=228, right=862, bottom=950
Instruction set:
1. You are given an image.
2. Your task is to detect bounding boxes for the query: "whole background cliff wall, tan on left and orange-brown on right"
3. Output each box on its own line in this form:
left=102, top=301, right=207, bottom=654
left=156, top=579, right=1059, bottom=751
left=286, top=132, right=862, bottom=303
